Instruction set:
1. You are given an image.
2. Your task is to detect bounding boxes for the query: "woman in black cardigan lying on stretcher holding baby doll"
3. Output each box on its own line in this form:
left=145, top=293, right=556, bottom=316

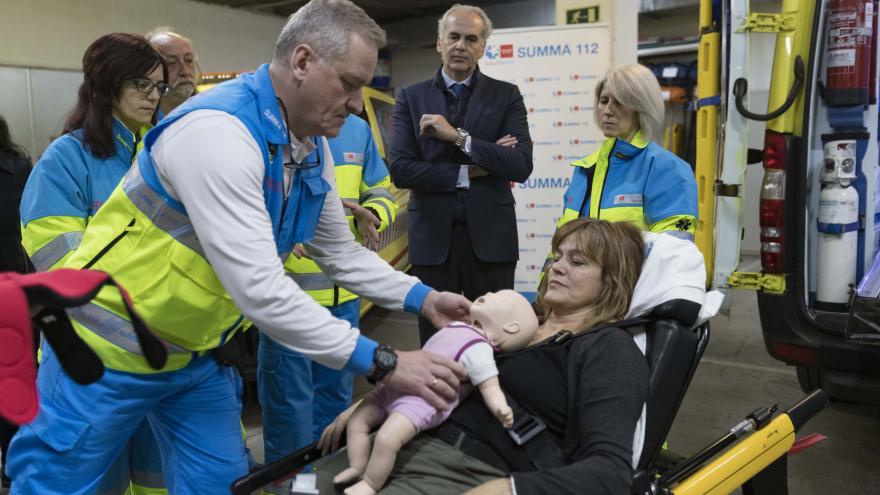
left=315, top=218, right=705, bottom=495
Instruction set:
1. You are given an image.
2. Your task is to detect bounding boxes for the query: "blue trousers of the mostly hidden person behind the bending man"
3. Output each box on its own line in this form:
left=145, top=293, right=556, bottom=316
left=257, top=299, right=361, bottom=463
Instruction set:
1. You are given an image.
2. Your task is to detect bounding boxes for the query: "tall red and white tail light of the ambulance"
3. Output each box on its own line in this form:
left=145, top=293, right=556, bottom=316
left=760, top=130, right=788, bottom=273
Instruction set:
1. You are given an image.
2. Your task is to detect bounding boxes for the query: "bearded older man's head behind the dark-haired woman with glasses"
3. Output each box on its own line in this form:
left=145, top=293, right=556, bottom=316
left=147, top=26, right=199, bottom=120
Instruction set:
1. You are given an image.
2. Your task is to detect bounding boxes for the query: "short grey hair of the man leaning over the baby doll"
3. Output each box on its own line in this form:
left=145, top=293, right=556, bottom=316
left=273, top=0, right=387, bottom=67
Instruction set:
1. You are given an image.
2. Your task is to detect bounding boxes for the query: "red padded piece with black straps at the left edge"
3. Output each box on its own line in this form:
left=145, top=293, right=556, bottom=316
left=0, top=269, right=168, bottom=424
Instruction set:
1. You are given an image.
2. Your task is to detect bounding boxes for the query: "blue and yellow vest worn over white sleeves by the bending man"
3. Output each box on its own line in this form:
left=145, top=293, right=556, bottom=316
left=64, top=65, right=331, bottom=373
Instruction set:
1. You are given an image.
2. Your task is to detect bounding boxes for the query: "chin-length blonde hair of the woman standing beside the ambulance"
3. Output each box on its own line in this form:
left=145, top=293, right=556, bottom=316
left=593, top=64, right=666, bottom=140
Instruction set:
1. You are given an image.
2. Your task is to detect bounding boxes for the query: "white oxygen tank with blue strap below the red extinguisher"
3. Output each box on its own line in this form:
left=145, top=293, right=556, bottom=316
left=816, top=140, right=859, bottom=305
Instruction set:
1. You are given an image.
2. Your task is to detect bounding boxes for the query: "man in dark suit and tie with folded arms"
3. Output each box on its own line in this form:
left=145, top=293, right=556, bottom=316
left=389, top=5, right=532, bottom=344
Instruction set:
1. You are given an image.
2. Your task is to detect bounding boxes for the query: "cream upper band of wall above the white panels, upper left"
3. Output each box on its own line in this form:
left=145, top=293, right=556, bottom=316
left=0, top=0, right=285, bottom=71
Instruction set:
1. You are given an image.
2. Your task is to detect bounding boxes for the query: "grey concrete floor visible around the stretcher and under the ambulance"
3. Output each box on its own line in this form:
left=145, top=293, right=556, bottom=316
left=245, top=292, right=880, bottom=495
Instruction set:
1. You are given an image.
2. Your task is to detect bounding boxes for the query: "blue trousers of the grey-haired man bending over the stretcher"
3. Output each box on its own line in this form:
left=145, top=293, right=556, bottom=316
left=8, top=346, right=247, bottom=495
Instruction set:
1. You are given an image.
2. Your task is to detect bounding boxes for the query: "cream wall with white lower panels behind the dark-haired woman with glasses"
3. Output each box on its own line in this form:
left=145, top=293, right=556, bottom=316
left=0, top=0, right=285, bottom=158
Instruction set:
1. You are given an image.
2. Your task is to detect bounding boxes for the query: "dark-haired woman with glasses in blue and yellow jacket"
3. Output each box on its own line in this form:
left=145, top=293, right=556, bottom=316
left=13, top=33, right=171, bottom=494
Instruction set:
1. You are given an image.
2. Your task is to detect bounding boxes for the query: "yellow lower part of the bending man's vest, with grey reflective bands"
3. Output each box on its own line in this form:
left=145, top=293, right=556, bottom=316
left=65, top=169, right=243, bottom=373
